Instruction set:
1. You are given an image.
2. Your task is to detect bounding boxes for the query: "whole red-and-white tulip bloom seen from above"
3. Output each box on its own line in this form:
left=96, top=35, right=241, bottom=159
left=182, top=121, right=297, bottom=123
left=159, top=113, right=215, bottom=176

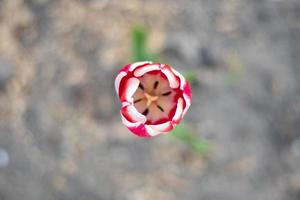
left=115, top=62, right=192, bottom=137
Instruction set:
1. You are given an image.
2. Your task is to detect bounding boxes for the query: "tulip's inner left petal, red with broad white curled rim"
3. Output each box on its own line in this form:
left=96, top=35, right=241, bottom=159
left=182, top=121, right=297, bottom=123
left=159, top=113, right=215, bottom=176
left=120, top=77, right=140, bottom=103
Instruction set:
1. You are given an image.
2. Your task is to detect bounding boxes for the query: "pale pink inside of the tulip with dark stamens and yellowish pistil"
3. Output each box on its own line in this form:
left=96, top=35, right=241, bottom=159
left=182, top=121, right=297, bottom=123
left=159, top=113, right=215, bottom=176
left=133, top=73, right=176, bottom=123
